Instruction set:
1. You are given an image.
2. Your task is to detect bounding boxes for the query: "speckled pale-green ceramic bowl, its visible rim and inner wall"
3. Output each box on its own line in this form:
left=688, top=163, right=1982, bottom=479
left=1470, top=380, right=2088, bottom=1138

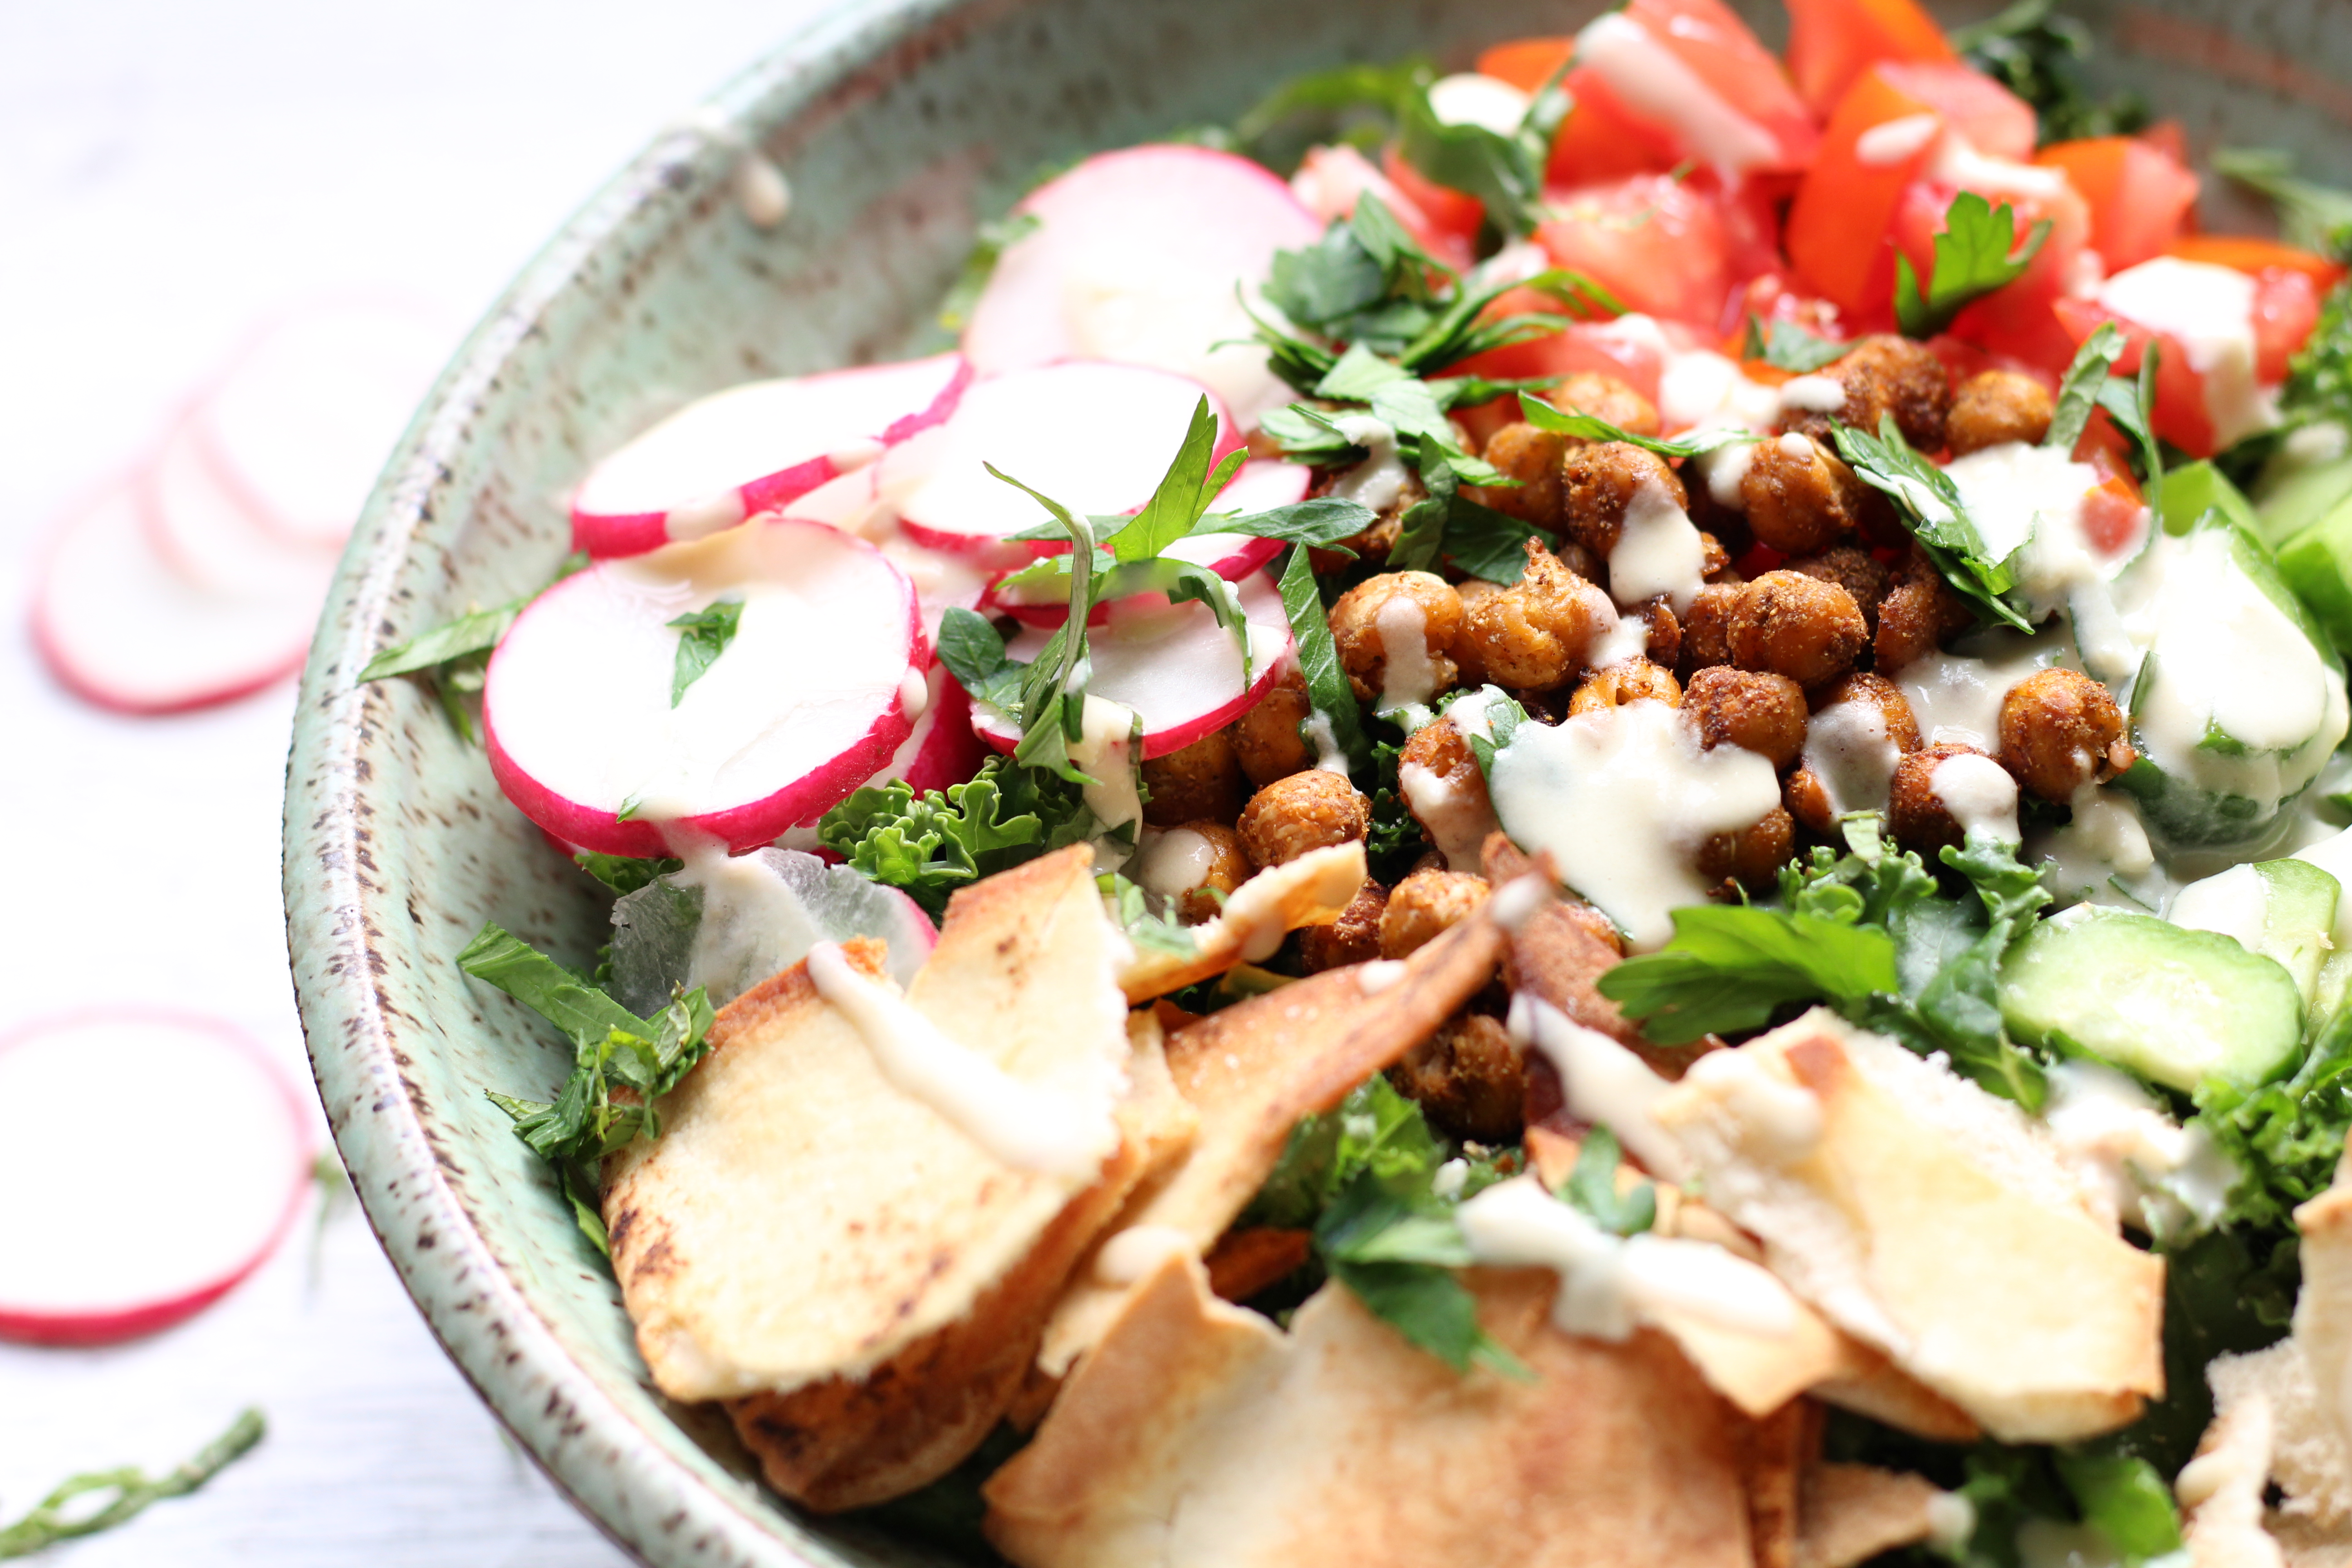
left=284, top=0, right=2352, bottom=1568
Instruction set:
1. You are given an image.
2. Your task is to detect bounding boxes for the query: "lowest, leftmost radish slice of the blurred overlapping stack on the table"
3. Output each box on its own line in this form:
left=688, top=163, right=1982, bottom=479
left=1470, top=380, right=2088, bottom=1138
left=33, top=484, right=318, bottom=715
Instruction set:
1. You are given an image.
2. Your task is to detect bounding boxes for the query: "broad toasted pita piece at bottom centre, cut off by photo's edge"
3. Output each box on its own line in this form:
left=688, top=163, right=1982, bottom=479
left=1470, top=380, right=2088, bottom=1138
left=983, top=1258, right=1752, bottom=1568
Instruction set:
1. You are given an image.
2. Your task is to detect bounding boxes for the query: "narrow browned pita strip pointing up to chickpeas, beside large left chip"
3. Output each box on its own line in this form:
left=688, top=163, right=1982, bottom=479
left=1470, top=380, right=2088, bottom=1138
left=1039, top=912, right=1503, bottom=1377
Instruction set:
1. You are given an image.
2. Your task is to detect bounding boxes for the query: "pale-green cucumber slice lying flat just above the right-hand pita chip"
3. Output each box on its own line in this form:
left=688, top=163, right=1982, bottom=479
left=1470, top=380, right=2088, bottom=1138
left=2002, top=912, right=2303, bottom=1091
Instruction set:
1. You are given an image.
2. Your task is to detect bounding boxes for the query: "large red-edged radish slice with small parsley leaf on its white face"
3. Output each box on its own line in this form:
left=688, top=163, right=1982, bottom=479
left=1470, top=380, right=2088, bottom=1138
left=482, top=522, right=929, bottom=856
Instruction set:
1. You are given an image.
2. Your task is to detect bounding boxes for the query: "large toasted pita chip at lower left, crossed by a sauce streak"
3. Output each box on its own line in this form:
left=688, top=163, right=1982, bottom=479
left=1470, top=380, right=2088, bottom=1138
left=604, top=846, right=1188, bottom=1509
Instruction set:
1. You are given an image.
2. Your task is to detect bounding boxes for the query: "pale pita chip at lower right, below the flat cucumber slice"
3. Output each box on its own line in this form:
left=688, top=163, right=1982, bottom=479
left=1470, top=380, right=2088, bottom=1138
left=1653, top=1009, right=2164, bottom=1441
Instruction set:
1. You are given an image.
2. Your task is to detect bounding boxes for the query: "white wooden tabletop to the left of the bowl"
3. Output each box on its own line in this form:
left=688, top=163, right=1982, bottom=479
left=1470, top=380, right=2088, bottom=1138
left=0, top=0, right=823, bottom=1568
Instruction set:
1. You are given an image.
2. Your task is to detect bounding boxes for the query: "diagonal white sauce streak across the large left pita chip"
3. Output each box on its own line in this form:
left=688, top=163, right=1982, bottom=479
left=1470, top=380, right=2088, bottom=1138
left=809, top=943, right=1120, bottom=1176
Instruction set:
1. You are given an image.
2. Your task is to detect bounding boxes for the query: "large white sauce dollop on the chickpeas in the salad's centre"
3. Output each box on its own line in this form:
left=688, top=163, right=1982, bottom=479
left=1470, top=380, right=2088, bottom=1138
left=1486, top=701, right=1780, bottom=952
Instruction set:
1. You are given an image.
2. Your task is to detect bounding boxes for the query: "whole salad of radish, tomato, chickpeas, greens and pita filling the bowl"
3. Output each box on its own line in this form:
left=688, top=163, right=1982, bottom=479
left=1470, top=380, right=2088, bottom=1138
left=348, top=0, right=2352, bottom=1568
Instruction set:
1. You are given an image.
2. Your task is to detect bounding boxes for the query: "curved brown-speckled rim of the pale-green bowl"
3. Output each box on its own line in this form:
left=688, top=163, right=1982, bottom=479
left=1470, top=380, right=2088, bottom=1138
left=280, top=0, right=964, bottom=1568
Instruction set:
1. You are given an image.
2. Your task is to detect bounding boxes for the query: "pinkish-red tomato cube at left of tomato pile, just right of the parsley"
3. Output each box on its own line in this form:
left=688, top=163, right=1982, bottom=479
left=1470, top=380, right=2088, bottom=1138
left=1536, top=174, right=1731, bottom=329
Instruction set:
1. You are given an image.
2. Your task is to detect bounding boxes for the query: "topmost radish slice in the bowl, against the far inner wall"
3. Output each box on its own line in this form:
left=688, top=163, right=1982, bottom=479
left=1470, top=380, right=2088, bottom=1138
left=964, top=146, right=1324, bottom=423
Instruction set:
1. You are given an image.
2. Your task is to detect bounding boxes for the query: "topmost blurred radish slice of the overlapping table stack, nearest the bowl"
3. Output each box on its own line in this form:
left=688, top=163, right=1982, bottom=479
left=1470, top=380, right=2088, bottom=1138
left=195, top=301, right=463, bottom=545
